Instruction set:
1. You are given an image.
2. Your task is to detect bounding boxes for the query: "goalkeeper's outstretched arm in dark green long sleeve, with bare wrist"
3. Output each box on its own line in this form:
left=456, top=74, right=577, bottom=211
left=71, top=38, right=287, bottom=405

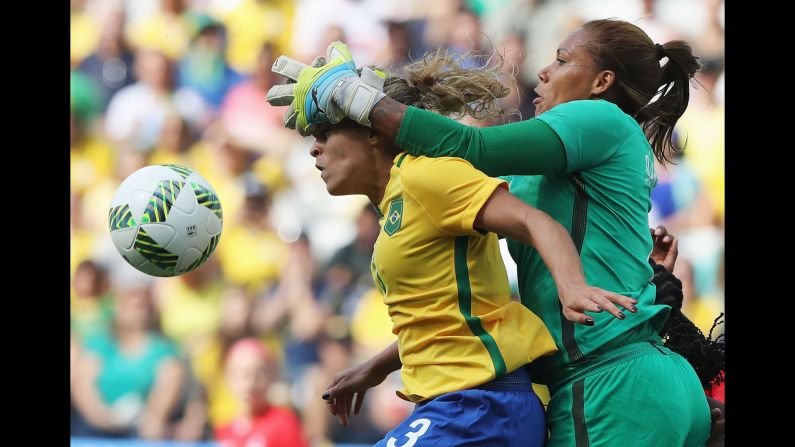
left=390, top=106, right=566, bottom=176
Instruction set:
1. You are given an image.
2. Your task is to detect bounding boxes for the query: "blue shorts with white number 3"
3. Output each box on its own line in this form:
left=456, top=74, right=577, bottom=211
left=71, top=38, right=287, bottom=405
left=374, top=368, right=547, bottom=447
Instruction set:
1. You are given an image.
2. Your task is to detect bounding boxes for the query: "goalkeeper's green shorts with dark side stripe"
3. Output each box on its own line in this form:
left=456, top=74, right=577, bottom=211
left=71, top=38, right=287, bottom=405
left=547, top=342, right=710, bottom=447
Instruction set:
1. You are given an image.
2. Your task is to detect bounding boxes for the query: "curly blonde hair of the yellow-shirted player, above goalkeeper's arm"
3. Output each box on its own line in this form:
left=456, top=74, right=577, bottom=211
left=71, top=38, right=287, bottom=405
left=382, top=49, right=510, bottom=120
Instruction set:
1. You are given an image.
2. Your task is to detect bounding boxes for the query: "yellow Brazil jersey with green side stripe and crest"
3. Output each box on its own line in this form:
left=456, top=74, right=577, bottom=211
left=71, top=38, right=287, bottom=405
left=371, top=153, right=557, bottom=402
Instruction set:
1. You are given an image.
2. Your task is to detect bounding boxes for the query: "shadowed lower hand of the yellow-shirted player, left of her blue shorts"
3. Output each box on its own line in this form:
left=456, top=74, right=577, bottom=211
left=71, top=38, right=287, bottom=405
left=323, top=362, right=386, bottom=427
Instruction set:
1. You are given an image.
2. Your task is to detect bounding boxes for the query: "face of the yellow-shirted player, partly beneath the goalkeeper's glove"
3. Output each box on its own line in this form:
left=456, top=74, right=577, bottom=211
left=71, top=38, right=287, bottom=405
left=309, top=124, right=375, bottom=196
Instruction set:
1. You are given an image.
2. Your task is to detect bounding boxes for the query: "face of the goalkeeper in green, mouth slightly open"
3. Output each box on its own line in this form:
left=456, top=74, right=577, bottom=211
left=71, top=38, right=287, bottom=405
left=533, top=29, right=597, bottom=116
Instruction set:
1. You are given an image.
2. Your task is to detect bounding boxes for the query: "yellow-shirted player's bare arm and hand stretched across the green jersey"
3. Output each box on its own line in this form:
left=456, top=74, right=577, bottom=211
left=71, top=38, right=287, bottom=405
left=475, top=188, right=637, bottom=326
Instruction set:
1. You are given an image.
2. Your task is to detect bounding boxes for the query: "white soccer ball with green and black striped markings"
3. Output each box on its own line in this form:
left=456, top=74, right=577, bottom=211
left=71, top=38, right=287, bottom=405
left=108, top=164, right=223, bottom=276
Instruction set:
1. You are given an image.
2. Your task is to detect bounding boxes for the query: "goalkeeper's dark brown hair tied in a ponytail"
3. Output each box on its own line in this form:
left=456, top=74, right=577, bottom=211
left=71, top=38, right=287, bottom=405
left=582, top=19, right=701, bottom=163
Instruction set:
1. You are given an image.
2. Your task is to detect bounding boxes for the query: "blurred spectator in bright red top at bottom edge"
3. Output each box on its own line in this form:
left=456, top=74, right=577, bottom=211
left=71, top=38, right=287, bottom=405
left=215, top=338, right=308, bottom=447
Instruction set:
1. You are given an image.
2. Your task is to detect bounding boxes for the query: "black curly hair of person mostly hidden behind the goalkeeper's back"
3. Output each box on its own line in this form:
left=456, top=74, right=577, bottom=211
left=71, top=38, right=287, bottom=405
left=649, top=260, right=726, bottom=390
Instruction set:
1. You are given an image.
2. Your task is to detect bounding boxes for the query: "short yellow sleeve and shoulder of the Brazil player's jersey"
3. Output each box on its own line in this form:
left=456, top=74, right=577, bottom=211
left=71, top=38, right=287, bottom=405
left=402, top=157, right=508, bottom=236
